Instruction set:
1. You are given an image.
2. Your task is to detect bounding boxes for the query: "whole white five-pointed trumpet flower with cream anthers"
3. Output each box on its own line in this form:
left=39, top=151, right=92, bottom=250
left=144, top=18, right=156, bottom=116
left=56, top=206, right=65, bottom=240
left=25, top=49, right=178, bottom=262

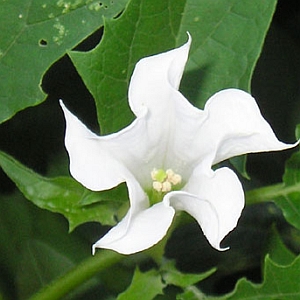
left=61, top=36, right=294, bottom=254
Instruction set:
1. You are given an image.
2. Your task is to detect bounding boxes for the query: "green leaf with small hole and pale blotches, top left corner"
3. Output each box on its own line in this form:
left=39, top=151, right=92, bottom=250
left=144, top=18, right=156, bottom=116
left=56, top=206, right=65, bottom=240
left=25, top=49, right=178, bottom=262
left=0, top=0, right=127, bottom=123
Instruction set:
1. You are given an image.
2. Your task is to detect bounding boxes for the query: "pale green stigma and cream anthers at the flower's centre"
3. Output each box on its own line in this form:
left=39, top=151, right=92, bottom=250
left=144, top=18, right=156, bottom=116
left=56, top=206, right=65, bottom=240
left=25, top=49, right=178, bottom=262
left=151, top=169, right=181, bottom=193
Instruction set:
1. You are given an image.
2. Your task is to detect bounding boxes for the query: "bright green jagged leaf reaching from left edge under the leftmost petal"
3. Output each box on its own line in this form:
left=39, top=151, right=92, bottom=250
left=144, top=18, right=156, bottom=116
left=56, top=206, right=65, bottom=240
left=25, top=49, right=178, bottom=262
left=0, top=152, right=127, bottom=230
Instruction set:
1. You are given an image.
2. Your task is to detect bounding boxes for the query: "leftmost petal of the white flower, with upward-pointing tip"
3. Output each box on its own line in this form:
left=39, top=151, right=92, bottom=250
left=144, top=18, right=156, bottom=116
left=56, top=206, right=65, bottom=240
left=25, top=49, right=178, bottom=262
left=60, top=101, right=155, bottom=191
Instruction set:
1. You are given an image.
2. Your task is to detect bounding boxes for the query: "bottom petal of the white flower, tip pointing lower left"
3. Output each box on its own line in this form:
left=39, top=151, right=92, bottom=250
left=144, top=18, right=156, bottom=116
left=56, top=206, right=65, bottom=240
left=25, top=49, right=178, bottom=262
left=93, top=202, right=175, bottom=254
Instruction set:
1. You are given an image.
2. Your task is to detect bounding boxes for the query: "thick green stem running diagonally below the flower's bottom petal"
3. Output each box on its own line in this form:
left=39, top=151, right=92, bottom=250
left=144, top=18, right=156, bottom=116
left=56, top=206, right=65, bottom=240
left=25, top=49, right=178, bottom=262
left=30, top=250, right=125, bottom=300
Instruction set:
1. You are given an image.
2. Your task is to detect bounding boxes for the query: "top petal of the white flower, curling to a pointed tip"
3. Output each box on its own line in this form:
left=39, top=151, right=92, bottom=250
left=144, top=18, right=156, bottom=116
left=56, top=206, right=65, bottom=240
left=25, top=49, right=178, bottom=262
left=128, top=35, right=192, bottom=119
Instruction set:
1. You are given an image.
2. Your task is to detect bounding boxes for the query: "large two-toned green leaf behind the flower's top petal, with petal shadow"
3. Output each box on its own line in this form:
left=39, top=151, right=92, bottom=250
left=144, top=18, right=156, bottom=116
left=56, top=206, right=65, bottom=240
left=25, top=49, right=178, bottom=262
left=69, top=0, right=276, bottom=134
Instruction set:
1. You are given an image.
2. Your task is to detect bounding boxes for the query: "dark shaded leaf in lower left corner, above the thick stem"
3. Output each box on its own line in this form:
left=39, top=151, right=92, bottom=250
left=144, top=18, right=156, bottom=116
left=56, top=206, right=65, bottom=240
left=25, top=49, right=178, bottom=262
left=0, top=191, right=91, bottom=299
